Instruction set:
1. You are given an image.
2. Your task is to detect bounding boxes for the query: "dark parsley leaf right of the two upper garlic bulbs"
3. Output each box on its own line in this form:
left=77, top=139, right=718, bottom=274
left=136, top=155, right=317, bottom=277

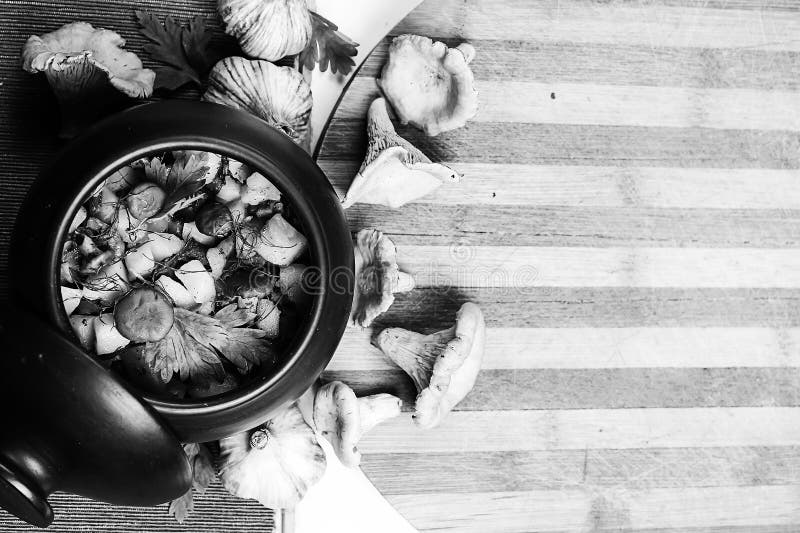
left=300, top=11, right=358, bottom=75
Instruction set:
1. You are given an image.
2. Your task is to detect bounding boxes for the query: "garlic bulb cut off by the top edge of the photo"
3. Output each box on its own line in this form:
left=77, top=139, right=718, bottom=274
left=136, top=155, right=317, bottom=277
left=219, top=0, right=312, bottom=61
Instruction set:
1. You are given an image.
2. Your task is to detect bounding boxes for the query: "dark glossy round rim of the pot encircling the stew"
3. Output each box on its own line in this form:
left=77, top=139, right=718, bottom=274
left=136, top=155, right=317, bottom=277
left=15, top=101, right=354, bottom=440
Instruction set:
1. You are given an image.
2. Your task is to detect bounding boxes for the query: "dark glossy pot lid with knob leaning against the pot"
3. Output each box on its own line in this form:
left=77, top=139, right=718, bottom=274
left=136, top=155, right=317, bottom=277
left=0, top=309, right=192, bottom=527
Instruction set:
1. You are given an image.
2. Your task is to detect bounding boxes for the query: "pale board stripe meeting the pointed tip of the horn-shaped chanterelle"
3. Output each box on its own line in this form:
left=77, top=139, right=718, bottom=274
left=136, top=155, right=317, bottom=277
left=320, top=160, right=800, bottom=209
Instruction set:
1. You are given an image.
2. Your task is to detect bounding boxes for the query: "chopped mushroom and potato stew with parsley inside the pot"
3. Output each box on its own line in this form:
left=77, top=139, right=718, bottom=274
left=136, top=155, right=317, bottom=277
left=59, top=150, right=313, bottom=398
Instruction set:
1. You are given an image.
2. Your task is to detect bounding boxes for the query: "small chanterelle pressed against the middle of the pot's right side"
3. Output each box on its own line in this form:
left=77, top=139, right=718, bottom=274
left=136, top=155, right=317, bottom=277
left=350, top=229, right=414, bottom=327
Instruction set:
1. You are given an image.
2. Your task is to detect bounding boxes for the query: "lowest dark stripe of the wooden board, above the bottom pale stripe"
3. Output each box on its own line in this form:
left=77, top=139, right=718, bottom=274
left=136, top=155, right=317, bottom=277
left=361, top=446, right=800, bottom=495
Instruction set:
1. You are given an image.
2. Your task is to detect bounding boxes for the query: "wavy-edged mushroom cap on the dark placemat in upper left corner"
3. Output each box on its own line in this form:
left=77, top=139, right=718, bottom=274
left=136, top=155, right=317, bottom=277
left=22, top=22, right=156, bottom=98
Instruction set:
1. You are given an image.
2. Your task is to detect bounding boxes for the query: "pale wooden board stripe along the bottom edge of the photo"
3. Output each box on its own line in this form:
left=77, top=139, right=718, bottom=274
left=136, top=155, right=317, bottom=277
left=389, top=485, right=800, bottom=533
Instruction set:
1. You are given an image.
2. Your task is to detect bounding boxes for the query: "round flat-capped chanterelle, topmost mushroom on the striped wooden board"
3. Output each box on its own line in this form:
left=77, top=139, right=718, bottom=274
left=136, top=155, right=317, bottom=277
left=378, top=35, right=478, bottom=135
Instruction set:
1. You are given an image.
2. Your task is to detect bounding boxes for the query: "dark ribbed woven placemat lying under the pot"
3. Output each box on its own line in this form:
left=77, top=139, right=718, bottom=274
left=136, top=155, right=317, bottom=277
left=0, top=0, right=273, bottom=533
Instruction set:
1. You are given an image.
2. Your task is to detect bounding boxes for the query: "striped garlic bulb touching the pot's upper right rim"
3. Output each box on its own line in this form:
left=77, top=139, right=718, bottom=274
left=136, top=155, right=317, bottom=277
left=203, top=57, right=312, bottom=143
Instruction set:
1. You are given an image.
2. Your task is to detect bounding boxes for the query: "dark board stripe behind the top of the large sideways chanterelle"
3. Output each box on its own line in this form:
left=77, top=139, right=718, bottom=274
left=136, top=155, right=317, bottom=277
left=374, top=287, right=800, bottom=332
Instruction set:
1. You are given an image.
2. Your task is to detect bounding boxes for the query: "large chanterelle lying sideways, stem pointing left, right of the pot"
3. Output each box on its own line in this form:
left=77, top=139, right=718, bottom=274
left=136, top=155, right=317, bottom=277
left=375, top=302, right=486, bottom=428
